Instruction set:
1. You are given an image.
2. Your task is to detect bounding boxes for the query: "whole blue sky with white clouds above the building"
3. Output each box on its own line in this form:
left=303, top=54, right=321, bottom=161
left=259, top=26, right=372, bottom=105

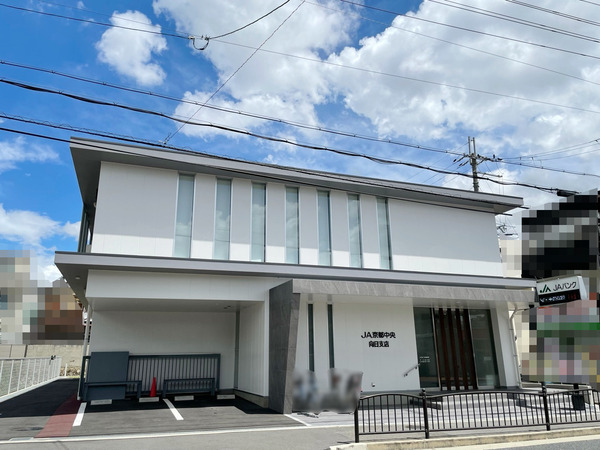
left=0, top=0, right=600, bottom=279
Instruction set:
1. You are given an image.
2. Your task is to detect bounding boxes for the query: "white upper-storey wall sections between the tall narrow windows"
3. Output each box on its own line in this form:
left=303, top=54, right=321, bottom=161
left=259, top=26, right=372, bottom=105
left=92, top=163, right=502, bottom=276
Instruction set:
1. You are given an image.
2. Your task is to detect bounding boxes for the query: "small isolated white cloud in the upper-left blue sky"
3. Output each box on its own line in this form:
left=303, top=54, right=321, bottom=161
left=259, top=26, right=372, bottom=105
left=96, top=11, right=167, bottom=86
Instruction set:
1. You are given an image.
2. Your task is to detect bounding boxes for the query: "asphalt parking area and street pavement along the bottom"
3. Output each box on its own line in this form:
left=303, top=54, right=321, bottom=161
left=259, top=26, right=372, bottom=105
left=0, top=379, right=600, bottom=450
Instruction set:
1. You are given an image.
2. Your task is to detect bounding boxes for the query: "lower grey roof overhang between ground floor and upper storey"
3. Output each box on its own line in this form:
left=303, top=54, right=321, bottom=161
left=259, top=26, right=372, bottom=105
left=55, top=252, right=535, bottom=312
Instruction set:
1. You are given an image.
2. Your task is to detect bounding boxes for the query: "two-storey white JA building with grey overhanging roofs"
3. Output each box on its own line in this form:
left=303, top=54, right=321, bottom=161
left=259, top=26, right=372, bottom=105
left=55, top=139, right=535, bottom=413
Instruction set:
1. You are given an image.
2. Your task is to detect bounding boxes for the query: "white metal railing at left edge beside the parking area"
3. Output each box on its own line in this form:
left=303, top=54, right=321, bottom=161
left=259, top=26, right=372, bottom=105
left=0, top=356, right=61, bottom=397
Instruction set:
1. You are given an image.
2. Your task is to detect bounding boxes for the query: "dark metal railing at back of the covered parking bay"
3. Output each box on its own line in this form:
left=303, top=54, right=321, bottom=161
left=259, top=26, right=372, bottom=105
left=79, top=353, right=221, bottom=395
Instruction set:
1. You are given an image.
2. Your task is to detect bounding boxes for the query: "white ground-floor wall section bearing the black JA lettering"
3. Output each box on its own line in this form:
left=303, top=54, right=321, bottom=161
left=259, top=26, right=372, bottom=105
left=333, top=302, right=420, bottom=391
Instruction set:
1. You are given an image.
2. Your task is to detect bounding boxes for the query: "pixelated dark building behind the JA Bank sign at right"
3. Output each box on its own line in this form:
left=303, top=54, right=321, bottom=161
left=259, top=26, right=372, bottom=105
left=522, top=190, right=600, bottom=387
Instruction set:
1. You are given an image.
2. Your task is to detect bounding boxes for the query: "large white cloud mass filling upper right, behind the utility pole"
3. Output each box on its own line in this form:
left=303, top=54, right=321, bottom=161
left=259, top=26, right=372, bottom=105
left=153, top=0, right=600, bottom=206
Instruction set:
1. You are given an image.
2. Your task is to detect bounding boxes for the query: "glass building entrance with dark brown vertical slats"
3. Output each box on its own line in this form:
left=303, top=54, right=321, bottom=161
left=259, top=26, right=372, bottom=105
left=414, top=308, right=499, bottom=390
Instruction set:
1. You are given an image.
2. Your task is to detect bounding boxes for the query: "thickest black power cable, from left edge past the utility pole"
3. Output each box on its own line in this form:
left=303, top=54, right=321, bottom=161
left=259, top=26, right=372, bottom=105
left=0, top=78, right=600, bottom=178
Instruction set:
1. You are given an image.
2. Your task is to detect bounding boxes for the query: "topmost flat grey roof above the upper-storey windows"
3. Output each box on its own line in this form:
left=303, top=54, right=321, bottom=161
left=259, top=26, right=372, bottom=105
left=70, top=137, right=523, bottom=214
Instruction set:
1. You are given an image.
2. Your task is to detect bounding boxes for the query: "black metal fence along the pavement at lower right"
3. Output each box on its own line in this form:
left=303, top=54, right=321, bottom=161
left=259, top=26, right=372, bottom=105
left=354, top=386, right=600, bottom=442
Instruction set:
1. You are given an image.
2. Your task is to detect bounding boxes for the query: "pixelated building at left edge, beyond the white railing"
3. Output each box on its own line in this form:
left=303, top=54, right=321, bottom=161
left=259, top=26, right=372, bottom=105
left=0, top=250, right=83, bottom=346
